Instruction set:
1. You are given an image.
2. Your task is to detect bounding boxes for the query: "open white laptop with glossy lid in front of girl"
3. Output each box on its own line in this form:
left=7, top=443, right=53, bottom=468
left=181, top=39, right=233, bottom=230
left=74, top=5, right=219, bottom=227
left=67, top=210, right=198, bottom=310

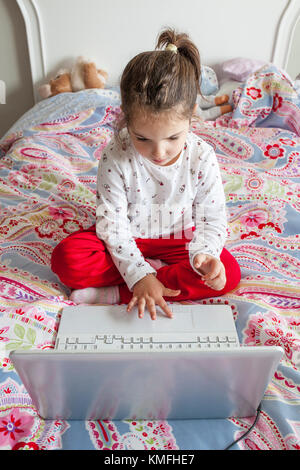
left=10, top=303, right=283, bottom=420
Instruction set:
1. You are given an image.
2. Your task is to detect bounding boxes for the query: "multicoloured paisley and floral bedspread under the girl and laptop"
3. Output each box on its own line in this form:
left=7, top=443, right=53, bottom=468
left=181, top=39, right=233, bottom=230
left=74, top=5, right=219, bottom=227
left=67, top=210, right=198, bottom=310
left=0, top=66, right=300, bottom=450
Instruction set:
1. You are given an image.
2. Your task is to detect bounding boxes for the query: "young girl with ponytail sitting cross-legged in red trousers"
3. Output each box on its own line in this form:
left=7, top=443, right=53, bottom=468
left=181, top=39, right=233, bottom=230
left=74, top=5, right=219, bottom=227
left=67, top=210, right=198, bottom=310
left=52, top=30, right=240, bottom=319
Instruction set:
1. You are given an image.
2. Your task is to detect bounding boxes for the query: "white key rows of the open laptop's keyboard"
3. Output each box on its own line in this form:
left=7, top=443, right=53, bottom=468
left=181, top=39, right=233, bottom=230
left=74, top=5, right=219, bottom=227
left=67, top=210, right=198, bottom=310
left=55, top=333, right=239, bottom=352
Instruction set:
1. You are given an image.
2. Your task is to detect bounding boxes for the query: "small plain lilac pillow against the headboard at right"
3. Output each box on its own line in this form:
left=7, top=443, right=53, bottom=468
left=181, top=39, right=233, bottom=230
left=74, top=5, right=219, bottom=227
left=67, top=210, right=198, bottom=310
left=221, top=57, right=266, bottom=82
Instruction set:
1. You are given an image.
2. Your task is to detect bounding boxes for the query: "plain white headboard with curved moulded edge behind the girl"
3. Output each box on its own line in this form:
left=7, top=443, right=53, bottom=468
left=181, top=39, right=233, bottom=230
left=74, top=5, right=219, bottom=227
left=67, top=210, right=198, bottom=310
left=17, top=0, right=300, bottom=101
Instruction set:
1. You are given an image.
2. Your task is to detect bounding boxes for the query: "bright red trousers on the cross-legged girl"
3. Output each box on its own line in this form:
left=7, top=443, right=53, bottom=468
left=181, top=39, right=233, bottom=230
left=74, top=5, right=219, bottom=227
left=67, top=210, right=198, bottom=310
left=51, top=225, right=241, bottom=304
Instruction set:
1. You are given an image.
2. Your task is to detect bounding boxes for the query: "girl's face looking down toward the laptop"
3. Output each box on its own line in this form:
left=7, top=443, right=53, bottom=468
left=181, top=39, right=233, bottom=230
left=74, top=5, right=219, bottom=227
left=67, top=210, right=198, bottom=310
left=128, top=107, right=190, bottom=166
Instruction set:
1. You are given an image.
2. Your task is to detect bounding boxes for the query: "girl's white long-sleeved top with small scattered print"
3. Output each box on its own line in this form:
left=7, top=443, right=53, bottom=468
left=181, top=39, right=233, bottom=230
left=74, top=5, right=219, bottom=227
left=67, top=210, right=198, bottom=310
left=96, top=132, right=227, bottom=291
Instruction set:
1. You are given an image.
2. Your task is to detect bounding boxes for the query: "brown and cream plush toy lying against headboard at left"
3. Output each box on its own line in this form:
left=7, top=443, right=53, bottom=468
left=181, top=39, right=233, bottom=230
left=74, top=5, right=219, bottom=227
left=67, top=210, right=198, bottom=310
left=39, top=57, right=108, bottom=99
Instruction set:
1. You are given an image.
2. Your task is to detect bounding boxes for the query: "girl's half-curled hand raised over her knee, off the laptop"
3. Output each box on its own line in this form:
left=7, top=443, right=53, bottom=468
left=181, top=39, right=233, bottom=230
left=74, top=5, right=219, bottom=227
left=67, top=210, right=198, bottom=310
left=194, top=253, right=226, bottom=290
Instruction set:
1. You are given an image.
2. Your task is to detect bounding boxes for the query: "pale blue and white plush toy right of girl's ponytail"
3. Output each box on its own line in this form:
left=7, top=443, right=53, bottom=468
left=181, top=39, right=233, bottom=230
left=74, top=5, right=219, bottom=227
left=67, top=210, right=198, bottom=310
left=197, top=65, right=232, bottom=121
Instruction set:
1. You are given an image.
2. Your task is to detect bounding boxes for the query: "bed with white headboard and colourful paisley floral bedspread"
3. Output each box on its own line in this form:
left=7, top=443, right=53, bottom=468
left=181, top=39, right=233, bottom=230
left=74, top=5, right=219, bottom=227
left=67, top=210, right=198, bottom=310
left=0, top=0, right=300, bottom=450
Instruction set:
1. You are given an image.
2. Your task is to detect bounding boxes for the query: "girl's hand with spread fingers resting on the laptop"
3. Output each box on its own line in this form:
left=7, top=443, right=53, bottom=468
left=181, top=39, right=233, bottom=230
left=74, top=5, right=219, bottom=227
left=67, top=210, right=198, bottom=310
left=127, top=274, right=180, bottom=320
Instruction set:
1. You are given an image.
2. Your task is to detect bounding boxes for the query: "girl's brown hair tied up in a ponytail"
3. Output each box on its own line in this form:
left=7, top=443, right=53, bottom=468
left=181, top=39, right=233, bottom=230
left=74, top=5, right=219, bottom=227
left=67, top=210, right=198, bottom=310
left=118, top=29, right=201, bottom=130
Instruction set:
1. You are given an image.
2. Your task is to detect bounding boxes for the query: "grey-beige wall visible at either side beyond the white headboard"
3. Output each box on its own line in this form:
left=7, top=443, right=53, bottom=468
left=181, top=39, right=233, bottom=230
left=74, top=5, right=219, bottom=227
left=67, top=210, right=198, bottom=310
left=0, top=0, right=300, bottom=138
